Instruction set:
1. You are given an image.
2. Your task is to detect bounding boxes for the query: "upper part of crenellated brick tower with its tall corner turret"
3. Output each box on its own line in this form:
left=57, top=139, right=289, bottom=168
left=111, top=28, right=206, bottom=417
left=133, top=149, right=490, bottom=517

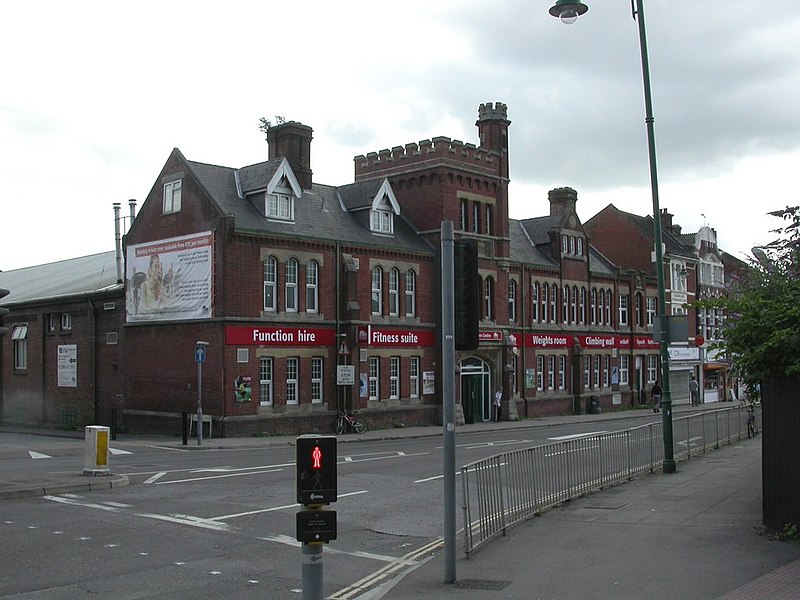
left=354, top=102, right=511, bottom=259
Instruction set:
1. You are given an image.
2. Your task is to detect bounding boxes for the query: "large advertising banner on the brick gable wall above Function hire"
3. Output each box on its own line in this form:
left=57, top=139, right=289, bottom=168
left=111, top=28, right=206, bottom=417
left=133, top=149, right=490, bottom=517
left=125, top=231, right=214, bottom=323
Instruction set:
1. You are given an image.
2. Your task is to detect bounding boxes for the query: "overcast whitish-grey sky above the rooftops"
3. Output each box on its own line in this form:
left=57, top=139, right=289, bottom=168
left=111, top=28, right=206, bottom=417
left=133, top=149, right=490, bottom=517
left=0, top=0, right=800, bottom=270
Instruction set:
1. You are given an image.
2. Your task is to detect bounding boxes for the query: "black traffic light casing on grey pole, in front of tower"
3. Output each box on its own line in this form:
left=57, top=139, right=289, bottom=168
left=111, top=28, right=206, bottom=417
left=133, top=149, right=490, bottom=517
left=453, top=240, right=481, bottom=350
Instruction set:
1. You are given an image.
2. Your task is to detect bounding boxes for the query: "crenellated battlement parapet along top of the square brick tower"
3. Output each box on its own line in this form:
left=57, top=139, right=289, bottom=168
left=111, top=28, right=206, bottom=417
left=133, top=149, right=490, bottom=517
left=353, top=136, right=496, bottom=177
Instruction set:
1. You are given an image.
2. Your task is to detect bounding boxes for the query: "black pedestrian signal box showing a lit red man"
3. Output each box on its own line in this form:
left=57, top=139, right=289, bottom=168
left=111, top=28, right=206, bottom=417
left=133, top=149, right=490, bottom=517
left=296, top=435, right=338, bottom=505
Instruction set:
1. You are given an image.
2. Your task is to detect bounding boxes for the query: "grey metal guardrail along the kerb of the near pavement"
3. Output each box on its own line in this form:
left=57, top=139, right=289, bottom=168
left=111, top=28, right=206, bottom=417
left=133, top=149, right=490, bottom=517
left=461, top=405, right=761, bottom=557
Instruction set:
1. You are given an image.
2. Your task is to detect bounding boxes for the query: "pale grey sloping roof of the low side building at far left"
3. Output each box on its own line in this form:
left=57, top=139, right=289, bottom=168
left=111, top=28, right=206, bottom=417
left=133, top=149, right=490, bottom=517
left=0, top=250, right=122, bottom=306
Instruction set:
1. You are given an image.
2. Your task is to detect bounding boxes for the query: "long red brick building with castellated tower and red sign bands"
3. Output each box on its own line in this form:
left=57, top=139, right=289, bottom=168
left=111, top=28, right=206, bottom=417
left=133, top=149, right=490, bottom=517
left=0, top=103, right=736, bottom=435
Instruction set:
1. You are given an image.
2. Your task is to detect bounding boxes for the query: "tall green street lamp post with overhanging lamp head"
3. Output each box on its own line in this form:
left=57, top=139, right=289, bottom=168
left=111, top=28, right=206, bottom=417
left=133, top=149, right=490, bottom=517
left=550, top=0, right=675, bottom=473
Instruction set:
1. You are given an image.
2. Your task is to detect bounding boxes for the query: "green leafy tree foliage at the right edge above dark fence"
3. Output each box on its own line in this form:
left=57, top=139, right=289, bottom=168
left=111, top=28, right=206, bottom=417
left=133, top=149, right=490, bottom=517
left=721, top=206, right=800, bottom=384
